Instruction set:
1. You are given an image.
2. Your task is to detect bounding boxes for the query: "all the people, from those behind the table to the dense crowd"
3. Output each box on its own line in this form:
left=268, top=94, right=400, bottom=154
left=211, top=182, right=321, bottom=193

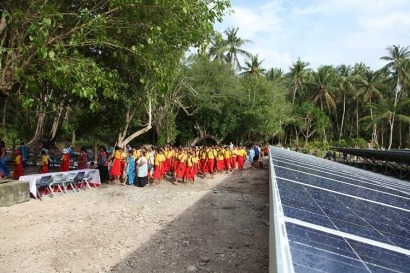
left=0, top=137, right=268, bottom=184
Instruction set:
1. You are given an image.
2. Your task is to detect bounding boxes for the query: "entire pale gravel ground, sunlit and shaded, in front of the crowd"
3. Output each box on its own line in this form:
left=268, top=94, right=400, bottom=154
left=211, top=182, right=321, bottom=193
left=0, top=160, right=269, bottom=273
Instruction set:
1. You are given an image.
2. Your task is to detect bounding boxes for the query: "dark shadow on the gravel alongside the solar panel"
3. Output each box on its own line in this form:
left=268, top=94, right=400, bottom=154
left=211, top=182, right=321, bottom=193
left=111, top=163, right=269, bottom=273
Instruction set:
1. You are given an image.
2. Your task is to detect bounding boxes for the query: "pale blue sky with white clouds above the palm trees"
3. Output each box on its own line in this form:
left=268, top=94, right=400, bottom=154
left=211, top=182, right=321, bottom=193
left=215, top=0, right=410, bottom=73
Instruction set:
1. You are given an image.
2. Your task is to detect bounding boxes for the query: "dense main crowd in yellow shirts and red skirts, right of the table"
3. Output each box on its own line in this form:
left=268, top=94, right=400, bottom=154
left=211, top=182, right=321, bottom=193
left=97, top=143, right=267, bottom=187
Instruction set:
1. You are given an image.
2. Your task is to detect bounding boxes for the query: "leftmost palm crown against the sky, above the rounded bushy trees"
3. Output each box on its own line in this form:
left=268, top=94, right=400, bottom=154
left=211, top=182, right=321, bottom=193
left=211, top=28, right=252, bottom=70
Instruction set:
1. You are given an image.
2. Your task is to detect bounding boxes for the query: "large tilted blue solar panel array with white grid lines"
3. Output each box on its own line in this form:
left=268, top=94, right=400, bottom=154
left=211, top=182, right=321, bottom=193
left=270, top=147, right=410, bottom=273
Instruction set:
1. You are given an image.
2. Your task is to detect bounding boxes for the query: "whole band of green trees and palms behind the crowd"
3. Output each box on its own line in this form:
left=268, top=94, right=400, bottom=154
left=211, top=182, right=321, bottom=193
left=0, top=0, right=410, bottom=156
